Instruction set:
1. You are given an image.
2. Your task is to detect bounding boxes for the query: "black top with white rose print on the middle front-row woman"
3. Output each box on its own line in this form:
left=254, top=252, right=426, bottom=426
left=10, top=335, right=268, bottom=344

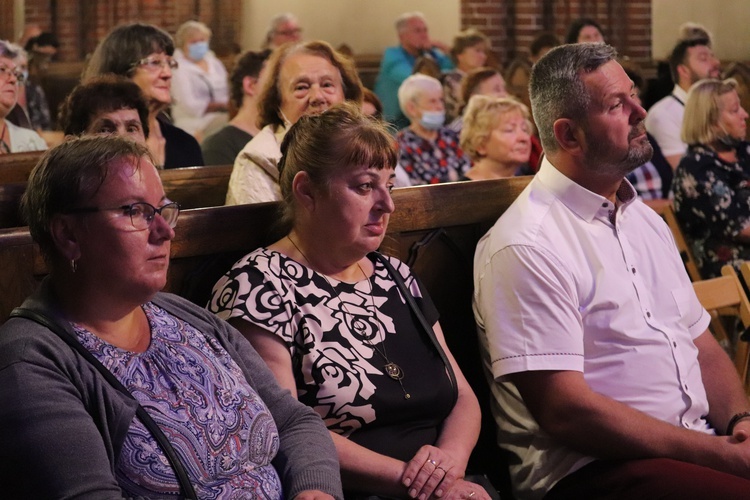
left=209, top=248, right=455, bottom=460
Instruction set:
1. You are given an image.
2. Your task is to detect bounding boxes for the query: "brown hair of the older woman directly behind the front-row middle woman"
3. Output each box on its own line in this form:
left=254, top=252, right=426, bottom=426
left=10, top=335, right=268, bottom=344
left=258, top=40, right=362, bottom=128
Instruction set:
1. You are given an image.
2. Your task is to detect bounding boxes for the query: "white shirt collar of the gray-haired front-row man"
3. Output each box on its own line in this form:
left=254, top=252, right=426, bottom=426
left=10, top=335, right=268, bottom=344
left=536, top=156, right=636, bottom=222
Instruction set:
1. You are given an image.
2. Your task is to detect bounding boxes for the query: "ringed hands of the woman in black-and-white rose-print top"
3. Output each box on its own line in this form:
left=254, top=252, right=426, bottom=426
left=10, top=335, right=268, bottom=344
left=401, top=445, right=462, bottom=500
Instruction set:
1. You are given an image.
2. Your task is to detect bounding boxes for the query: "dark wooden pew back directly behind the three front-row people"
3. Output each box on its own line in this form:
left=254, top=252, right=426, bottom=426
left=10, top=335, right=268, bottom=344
left=0, top=177, right=530, bottom=498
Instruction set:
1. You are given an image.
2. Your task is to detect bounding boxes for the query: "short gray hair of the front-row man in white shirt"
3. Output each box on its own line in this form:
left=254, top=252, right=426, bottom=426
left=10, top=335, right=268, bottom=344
left=529, top=43, right=617, bottom=152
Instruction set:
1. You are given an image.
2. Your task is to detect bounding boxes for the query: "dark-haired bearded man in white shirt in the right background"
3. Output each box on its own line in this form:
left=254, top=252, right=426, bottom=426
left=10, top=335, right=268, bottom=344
left=646, top=37, right=721, bottom=169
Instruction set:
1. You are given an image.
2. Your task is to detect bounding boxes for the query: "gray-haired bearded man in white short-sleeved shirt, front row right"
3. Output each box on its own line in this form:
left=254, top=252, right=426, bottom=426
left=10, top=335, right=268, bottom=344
left=474, top=44, right=750, bottom=499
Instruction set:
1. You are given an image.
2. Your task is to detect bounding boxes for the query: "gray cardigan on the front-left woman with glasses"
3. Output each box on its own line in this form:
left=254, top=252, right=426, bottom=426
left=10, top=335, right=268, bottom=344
left=0, top=283, right=343, bottom=499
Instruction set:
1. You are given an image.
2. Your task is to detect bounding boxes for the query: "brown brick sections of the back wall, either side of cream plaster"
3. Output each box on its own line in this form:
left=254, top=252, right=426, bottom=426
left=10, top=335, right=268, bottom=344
left=17, top=0, right=652, bottom=66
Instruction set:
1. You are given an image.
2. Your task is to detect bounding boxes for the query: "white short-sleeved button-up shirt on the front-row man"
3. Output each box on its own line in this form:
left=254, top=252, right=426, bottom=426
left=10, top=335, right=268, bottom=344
left=474, top=160, right=713, bottom=498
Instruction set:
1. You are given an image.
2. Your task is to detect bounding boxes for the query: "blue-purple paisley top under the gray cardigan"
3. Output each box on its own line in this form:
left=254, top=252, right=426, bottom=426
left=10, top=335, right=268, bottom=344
left=73, top=303, right=283, bottom=499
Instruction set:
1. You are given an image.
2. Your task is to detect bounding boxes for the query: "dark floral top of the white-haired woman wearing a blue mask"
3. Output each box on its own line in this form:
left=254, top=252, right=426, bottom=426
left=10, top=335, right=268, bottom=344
left=396, top=127, right=471, bottom=186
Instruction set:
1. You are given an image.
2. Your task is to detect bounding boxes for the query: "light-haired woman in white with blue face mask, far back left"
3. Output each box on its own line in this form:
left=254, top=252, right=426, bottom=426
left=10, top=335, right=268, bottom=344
left=172, top=21, right=229, bottom=141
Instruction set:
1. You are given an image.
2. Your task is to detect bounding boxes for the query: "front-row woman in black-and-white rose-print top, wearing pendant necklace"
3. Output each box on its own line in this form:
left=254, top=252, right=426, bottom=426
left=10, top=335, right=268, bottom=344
left=209, top=104, right=488, bottom=499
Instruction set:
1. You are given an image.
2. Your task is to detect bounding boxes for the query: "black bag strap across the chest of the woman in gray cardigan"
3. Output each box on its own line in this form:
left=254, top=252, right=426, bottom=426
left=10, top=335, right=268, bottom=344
left=10, top=307, right=198, bottom=500
